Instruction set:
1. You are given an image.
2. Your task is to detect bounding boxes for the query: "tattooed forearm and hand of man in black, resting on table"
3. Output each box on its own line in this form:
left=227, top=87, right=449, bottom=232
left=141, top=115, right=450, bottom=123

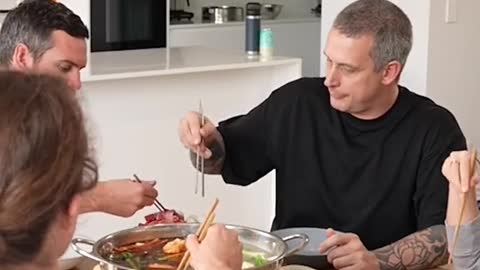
left=320, top=225, right=448, bottom=270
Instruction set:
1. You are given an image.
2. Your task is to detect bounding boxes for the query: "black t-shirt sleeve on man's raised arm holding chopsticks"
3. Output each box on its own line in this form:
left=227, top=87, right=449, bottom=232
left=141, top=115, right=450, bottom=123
left=217, top=79, right=309, bottom=186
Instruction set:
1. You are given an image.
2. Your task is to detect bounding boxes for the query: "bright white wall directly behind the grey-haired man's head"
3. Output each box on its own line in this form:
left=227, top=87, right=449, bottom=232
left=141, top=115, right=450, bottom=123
left=320, top=0, right=432, bottom=94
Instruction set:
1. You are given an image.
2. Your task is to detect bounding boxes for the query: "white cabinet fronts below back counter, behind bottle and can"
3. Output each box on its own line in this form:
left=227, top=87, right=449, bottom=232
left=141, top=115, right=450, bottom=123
left=169, top=18, right=321, bottom=76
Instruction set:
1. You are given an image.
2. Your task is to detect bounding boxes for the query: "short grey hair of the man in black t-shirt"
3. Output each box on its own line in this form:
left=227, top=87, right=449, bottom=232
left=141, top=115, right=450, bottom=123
left=333, top=0, right=412, bottom=71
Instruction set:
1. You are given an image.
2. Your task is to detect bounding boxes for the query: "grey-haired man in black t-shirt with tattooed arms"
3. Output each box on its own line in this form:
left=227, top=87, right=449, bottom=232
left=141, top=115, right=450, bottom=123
left=179, top=0, right=466, bottom=269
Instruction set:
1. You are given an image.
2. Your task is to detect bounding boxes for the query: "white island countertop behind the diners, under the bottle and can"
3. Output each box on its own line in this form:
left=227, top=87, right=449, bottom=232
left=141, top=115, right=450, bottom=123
left=82, top=46, right=301, bottom=82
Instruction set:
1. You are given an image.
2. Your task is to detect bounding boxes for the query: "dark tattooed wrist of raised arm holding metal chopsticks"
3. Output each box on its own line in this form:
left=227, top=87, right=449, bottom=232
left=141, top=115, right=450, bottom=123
left=190, top=131, right=225, bottom=174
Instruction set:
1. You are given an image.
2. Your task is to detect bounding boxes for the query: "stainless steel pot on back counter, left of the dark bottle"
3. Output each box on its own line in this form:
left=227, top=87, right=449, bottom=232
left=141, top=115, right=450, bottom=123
left=202, top=6, right=244, bottom=23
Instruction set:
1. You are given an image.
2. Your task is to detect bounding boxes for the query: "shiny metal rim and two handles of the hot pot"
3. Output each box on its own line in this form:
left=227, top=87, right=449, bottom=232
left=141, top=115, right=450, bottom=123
left=72, top=224, right=308, bottom=270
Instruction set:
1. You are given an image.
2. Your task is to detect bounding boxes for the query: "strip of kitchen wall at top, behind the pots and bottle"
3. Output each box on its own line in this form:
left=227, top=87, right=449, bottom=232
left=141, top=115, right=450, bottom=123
left=177, top=0, right=317, bottom=18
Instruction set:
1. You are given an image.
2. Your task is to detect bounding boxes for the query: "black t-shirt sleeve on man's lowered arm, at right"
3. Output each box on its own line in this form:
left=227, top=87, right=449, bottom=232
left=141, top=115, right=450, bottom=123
left=414, top=107, right=466, bottom=230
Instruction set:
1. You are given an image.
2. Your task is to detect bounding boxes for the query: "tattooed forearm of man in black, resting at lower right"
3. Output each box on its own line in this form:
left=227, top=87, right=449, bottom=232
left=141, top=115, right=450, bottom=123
left=373, top=225, right=448, bottom=269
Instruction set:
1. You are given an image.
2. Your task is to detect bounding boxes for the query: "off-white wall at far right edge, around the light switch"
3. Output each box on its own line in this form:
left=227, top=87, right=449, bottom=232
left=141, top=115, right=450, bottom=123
left=427, top=0, right=480, bottom=148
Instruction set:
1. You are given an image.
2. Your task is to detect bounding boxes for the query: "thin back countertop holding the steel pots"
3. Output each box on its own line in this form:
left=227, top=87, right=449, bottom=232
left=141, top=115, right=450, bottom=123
left=170, top=16, right=321, bottom=29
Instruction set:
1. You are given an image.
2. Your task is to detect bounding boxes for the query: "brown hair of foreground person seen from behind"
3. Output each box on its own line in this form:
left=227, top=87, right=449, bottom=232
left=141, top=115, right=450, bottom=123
left=0, top=71, right=98, bottom=269
